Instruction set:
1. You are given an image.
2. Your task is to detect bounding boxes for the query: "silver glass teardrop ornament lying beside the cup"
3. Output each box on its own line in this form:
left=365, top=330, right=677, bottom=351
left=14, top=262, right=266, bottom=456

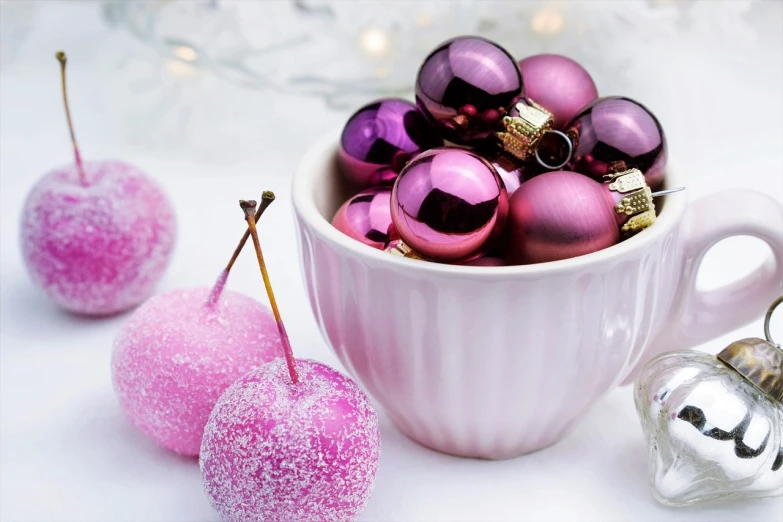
left=634, top=297, right=783, bottom=506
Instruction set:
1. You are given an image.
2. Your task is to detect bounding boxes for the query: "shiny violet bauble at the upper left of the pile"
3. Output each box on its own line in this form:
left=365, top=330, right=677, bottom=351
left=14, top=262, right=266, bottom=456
left=339, top=98, right=443, bottom=187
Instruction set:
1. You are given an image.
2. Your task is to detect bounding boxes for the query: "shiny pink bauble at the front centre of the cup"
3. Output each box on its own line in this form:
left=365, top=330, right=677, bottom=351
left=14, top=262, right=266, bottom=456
left=392, top=147, right=508, bottom=261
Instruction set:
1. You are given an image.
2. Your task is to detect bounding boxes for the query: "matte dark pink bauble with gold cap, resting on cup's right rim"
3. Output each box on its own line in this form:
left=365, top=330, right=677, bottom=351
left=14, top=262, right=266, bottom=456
left=507, top=169, right=680, bottom=264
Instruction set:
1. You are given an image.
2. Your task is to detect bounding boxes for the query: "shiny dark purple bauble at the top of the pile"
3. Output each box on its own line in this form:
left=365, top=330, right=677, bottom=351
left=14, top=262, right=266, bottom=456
left=416, top=36, right=524, bottom=144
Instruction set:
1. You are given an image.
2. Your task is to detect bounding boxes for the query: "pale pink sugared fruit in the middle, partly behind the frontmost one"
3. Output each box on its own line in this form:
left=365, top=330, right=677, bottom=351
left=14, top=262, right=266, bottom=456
left=112, top=272, right=283, bottom=456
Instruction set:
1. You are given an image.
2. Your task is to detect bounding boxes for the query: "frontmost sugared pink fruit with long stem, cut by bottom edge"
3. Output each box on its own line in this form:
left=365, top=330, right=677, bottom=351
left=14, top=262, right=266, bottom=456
left=199, top=202, right=381, bottom=522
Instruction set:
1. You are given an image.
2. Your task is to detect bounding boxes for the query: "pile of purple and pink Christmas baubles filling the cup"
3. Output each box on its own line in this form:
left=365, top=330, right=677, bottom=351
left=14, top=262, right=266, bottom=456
left=332, top=36, right=666, bottom=266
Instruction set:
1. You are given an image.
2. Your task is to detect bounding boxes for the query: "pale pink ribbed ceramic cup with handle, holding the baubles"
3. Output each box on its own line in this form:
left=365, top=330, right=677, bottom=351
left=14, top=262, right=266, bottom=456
left=293, top=129, right=783, bottom=459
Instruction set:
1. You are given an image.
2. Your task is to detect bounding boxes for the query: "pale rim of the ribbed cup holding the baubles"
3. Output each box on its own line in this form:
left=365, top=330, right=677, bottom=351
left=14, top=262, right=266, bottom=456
left=291, top=129, right=688, bottom=280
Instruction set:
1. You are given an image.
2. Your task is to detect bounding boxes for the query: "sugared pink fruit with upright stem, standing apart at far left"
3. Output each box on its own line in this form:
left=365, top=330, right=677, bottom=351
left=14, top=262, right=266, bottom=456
left=21, top=53, right=176, bottom=315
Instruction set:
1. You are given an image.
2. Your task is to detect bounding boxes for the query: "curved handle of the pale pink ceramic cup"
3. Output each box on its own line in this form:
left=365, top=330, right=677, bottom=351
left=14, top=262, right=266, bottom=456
left=625, top=190, right=783, bottom=384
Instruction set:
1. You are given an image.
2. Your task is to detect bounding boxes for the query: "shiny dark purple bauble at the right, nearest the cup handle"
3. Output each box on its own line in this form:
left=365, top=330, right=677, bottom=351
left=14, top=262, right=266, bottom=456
left=566, top=96, right=666, bottom=186
